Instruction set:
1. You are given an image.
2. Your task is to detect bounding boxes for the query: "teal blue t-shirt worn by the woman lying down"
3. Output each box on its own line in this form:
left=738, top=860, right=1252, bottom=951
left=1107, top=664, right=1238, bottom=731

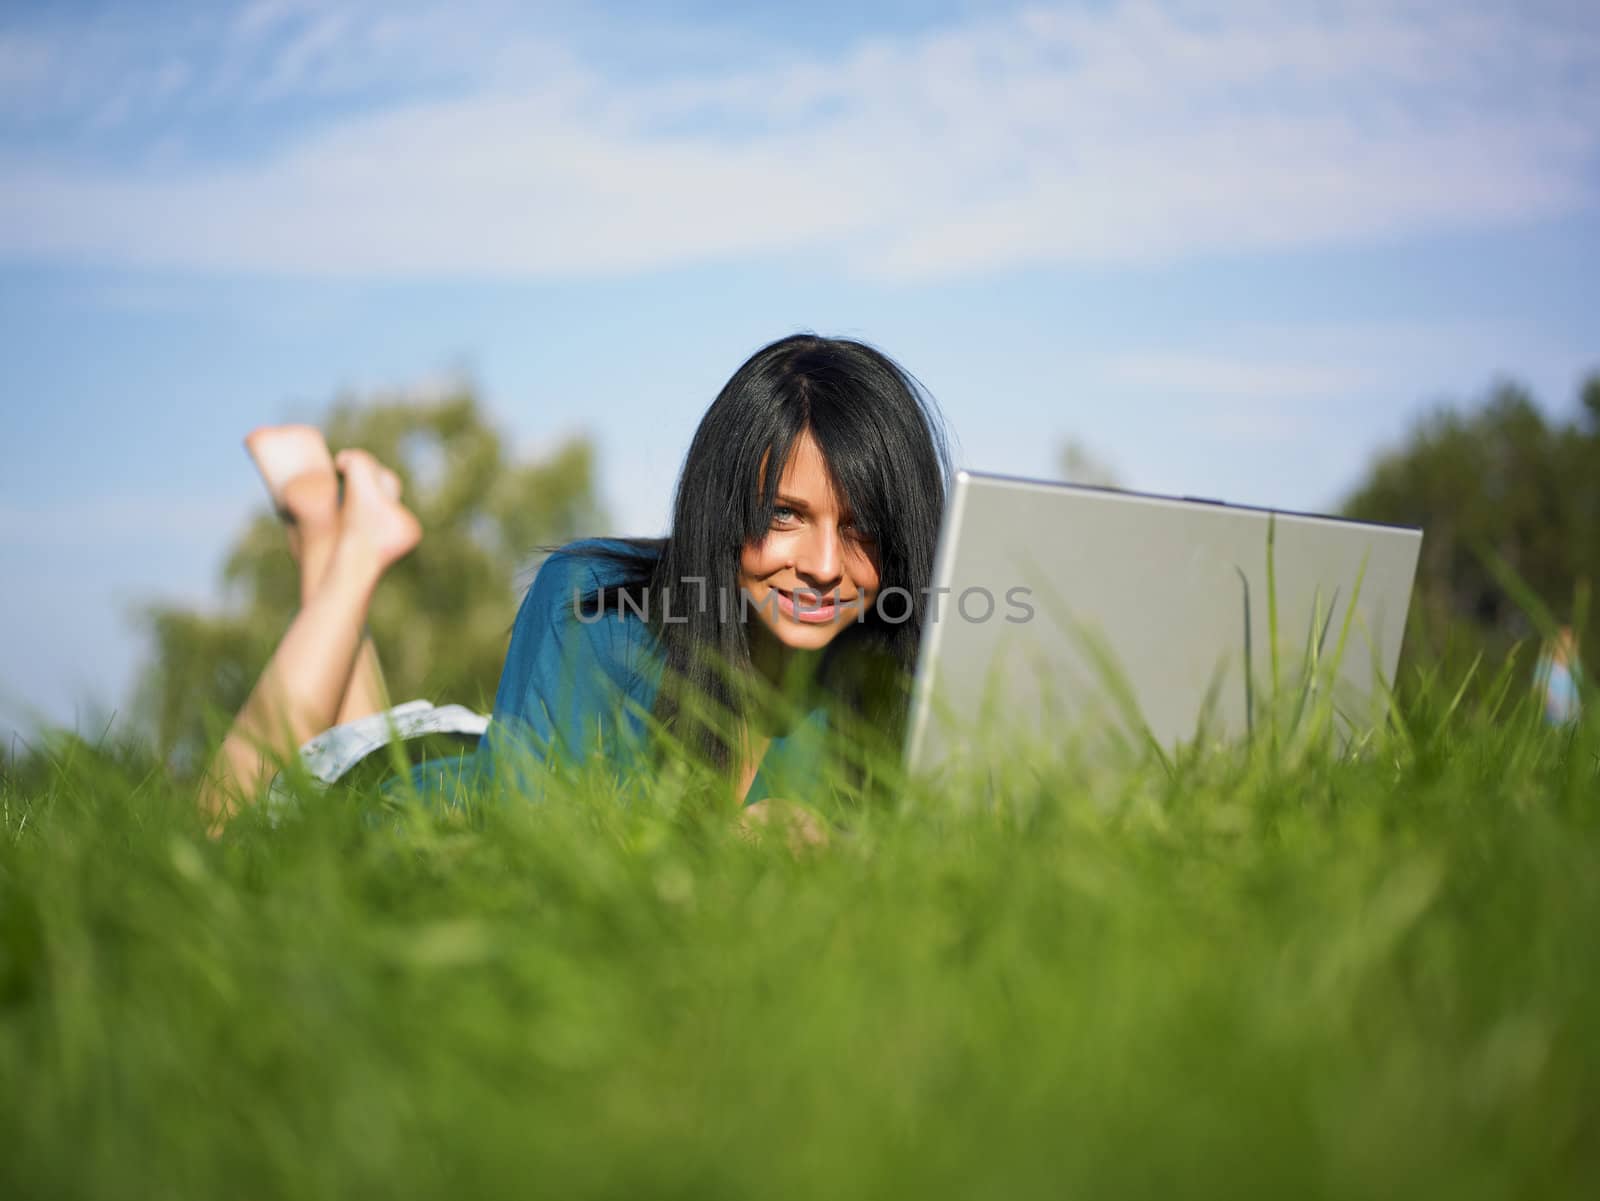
left=411, top=539, right=827, bottom=804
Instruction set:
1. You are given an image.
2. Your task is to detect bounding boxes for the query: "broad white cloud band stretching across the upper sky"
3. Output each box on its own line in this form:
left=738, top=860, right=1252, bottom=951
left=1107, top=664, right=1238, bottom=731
left=0, top=0, right=1600, bottom=278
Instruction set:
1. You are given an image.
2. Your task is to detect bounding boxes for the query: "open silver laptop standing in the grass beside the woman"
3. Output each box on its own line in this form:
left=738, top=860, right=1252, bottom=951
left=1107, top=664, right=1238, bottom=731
left=906, top=472, right=1422, bottom=771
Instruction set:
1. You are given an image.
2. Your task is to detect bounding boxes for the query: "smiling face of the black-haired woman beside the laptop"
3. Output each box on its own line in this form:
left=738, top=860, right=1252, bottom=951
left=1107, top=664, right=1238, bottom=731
left=739, top=432, right=878, bottom=651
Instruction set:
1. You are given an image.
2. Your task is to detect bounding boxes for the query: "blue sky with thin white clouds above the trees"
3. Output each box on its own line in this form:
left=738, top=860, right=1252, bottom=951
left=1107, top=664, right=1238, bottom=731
left=0, top=0, right=1600, bottom=748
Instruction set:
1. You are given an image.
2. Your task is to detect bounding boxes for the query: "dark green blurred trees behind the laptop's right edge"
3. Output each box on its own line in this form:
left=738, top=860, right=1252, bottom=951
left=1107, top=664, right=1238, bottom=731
left=1344, top=374, right=1600, bottom=678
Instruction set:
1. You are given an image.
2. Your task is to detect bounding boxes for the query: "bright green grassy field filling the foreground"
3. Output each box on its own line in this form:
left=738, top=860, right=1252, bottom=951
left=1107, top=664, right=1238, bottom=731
left=0, top=681, right=1600, bottom=1201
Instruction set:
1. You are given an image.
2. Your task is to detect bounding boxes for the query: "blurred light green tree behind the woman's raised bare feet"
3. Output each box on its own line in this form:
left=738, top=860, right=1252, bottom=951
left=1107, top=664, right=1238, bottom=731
left=134, top=384, right=605, bottom=771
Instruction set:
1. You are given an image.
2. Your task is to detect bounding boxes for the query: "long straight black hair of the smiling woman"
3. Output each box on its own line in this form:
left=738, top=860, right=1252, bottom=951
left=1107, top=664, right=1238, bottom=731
left=590, top=334, right=950, bottom=768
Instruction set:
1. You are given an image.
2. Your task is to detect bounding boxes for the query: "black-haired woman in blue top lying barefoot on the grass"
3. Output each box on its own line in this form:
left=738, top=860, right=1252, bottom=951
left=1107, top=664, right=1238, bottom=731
left=205, top=334, right=949, bottom=820
